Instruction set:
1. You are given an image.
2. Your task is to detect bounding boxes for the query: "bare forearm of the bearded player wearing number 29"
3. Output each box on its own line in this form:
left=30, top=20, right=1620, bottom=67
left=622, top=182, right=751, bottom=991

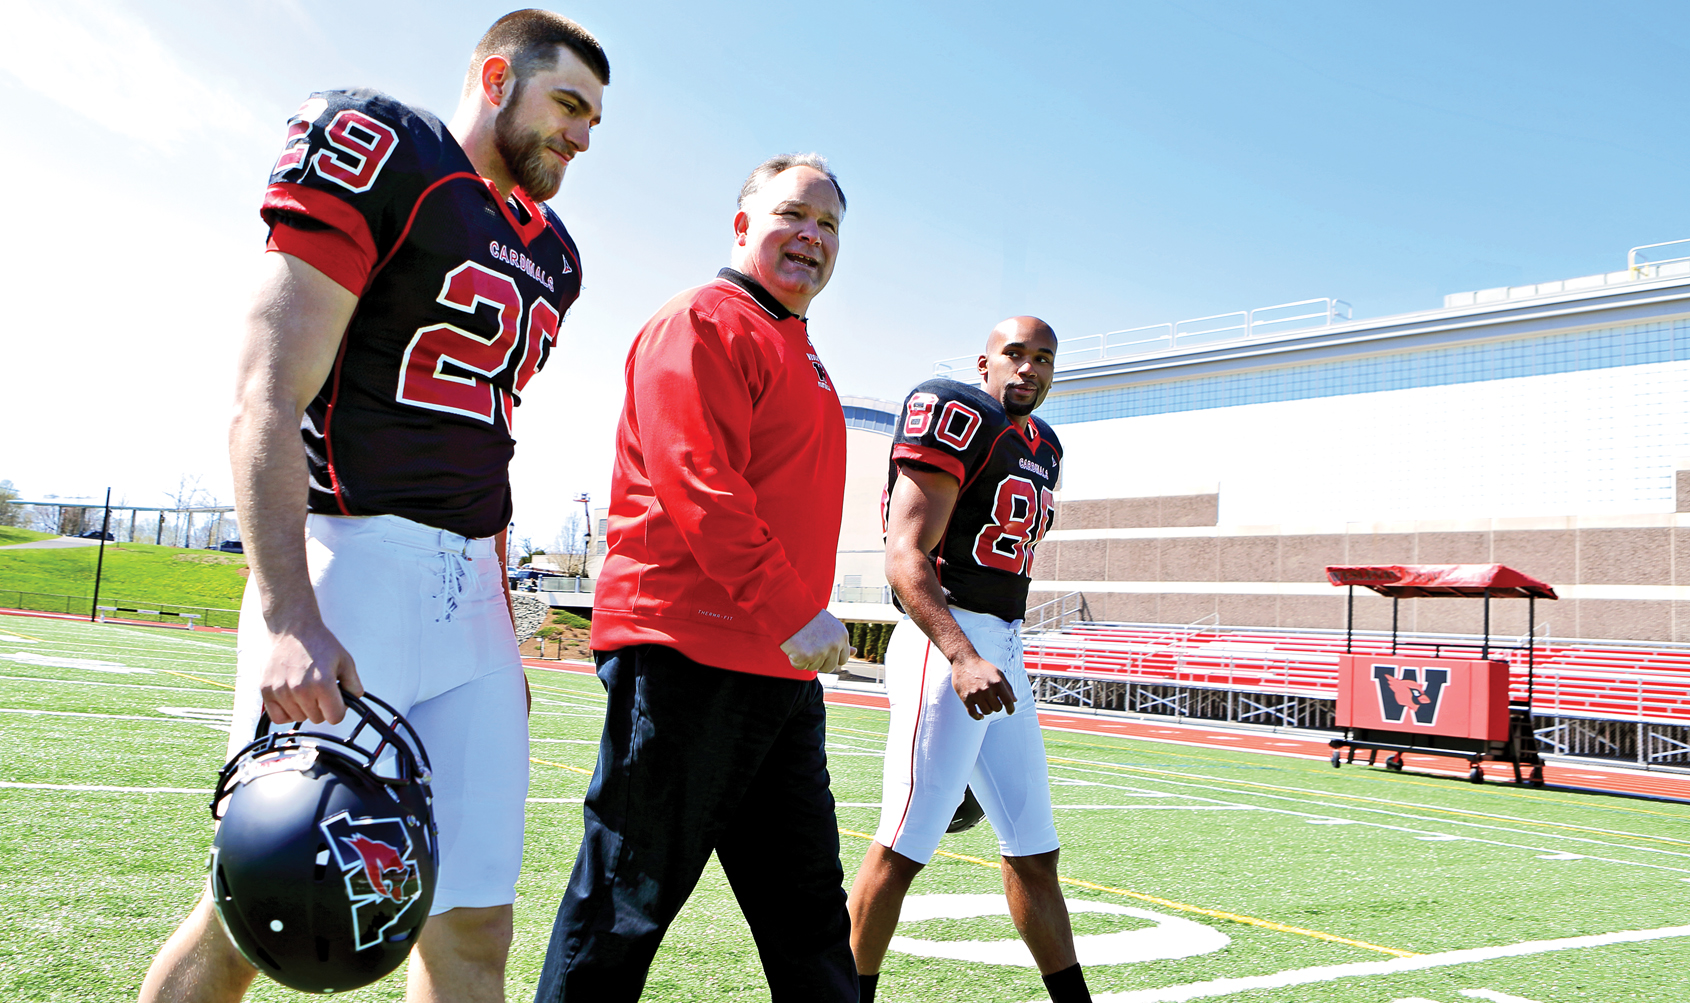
left=228, top=394, right=321, bottom=633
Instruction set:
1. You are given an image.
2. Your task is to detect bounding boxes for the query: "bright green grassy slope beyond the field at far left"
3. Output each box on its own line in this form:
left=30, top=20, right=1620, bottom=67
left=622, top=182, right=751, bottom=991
left=0, top=543, right=247, bottom=626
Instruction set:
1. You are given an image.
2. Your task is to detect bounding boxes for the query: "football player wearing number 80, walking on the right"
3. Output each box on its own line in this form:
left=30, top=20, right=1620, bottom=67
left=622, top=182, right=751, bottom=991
left=850, top=316, right=1090, bottom=1003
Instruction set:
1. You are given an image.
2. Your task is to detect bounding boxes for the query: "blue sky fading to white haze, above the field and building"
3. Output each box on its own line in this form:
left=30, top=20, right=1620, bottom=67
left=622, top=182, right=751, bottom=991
left=0, top=0, right=1690, bottom=540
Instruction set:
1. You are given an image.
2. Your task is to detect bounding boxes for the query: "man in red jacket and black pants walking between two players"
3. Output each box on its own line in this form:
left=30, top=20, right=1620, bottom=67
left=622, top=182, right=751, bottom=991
left=536, top=154, right=857, bottom=1003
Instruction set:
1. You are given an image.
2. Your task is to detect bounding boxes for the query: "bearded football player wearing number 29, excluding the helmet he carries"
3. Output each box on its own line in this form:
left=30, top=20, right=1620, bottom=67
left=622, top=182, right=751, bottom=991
left=140, top=10, right=610, bottom=1003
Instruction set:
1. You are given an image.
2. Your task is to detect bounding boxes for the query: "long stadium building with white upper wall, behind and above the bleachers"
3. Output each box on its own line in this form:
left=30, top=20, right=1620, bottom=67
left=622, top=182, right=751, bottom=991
left=938, top=244, right=1690, bottom=641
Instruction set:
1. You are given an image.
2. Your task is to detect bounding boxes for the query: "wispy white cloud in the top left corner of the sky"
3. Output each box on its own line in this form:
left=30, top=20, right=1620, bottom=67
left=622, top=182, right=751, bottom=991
left=0, top=0, right=275, bottom=152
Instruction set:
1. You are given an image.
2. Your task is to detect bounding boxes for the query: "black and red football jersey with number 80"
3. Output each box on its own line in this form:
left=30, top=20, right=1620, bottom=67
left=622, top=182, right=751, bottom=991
left=886, top=379, right=1061, bottom=621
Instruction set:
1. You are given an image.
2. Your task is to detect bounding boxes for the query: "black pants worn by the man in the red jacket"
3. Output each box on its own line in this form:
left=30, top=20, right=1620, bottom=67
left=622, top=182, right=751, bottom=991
left=534, top=644, right=857, bottom=1003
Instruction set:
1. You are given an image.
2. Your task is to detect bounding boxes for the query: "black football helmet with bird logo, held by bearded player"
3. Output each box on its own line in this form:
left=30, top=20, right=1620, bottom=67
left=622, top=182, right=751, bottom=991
left=211, top=690, right=439, bottom=993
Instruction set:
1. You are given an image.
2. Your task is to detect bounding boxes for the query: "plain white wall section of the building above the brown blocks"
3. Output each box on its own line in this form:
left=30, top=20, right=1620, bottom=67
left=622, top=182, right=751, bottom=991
left=1056, top=362, right=1690, bottom=526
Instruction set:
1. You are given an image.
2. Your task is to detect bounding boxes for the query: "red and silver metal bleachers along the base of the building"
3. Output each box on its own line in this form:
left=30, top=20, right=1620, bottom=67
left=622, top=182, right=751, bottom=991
left=1024, top=621, right=1690, bottom=770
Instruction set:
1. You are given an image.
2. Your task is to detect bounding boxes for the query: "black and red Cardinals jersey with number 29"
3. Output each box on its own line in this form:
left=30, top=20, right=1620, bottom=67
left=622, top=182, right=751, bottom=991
left=262, top=90, right=581, bottom=536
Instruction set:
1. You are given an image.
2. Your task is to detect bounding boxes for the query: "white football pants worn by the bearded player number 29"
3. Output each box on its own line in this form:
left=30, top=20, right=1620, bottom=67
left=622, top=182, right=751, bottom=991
left=228, top=514, right=529, bottom=915
